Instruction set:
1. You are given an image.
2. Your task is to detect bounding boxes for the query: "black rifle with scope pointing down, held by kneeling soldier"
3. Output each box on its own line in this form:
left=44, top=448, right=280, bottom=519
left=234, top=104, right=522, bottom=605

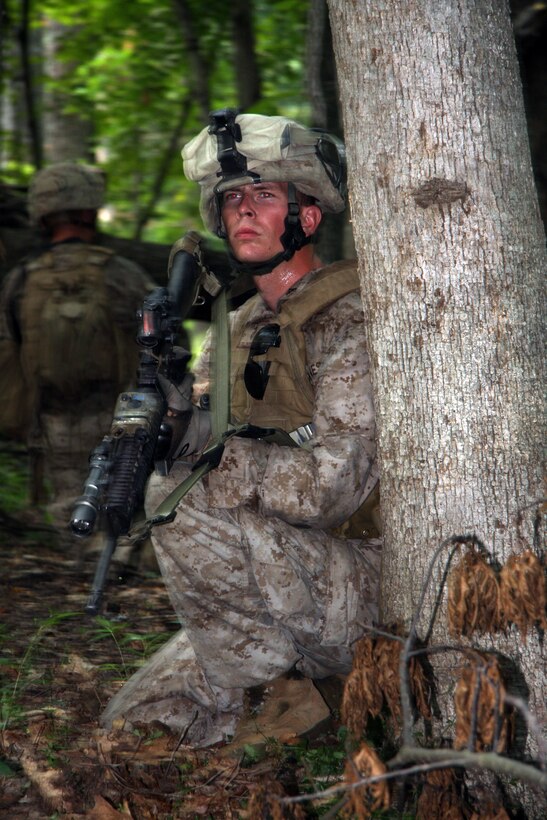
left=70, top=231, right=208, bottom=615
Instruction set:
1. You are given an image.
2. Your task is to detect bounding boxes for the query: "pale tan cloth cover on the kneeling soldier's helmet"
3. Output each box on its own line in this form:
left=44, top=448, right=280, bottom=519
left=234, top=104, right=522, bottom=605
left=182, top=114, right=346, bottom=232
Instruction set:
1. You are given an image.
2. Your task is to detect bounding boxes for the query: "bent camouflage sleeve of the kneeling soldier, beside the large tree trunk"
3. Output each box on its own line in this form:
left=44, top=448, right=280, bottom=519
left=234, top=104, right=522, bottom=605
left=207, top=294, right=378, bottom=529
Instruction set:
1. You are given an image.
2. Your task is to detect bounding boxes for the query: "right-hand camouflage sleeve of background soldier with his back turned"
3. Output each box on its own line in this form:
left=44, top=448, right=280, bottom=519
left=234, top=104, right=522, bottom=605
left=105, top=254, right=158, bottom=332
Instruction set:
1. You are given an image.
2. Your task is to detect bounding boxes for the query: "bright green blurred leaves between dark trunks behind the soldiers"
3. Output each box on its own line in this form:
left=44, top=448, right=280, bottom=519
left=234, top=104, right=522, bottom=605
left=2, top=0, right=308, bottom=242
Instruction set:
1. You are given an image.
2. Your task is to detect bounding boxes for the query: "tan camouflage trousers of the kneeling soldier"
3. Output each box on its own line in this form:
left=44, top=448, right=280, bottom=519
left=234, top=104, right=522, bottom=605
left=102, top=465, right=381, bottom=746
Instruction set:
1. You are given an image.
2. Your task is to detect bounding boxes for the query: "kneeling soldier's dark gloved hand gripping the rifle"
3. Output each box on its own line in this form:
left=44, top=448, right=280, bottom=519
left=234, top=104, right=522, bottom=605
left=155, top=373, right=211, bottom=462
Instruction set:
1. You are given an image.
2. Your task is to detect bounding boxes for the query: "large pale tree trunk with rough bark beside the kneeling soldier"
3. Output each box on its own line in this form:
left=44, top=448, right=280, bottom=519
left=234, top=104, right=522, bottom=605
left=329, top=0, right=546, bottom=817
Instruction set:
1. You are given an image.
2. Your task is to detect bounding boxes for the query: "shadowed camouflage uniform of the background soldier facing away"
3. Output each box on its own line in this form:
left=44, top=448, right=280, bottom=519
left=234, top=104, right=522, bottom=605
left=0, top=241, right=156, bottom=532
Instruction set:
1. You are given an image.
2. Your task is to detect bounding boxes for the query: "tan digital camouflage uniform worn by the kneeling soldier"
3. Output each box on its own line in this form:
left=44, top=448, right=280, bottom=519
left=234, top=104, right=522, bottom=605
left=101, top=264, right=381, bottom=746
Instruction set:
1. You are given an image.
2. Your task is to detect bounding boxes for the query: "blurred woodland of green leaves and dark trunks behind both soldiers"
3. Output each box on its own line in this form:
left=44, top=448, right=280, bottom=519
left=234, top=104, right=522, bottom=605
left=0, top=0, right=547, bottom=278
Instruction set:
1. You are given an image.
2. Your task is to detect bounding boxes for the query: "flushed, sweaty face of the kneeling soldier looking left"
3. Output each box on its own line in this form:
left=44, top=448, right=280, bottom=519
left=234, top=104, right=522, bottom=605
left=221, top=182, right=288, bottom=262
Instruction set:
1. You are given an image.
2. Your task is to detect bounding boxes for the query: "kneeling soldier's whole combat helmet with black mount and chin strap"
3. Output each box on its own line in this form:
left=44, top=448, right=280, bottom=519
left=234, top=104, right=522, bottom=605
left=182, top=108, right=346, bottom=274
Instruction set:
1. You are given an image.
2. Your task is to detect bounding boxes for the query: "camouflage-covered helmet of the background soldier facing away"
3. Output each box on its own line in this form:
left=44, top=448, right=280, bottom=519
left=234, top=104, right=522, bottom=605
left=28, top=162, right=105, bottom=221
